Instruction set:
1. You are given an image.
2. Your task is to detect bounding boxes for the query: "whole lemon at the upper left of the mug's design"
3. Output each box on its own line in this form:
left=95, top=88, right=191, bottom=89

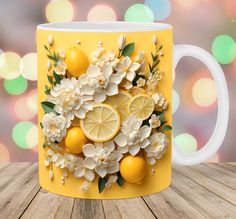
left=65, top=46, right=89, bottom=77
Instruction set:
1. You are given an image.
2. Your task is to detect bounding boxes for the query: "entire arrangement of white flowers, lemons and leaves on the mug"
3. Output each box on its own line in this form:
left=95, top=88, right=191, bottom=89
left=40, top=35, right=171, bottom=193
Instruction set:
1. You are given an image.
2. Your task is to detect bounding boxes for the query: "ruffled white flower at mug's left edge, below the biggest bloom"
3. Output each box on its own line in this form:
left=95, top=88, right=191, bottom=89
left=42, top=112, right=69, bottom=142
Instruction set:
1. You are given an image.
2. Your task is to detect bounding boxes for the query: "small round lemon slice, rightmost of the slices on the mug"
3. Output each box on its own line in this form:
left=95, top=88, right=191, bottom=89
left=128, top=94, right=154, bottom=120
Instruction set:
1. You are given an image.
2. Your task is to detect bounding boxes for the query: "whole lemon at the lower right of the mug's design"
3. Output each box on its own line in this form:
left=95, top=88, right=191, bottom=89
left=120, top=155, right=147, bottom=183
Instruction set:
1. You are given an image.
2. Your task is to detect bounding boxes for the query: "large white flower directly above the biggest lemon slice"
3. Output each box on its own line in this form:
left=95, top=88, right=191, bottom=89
left=87, top=65, right=122, bottom=103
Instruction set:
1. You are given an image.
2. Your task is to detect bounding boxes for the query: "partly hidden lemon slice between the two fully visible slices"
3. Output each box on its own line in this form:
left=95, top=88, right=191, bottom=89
left=105, top=90, right=133, bottom=121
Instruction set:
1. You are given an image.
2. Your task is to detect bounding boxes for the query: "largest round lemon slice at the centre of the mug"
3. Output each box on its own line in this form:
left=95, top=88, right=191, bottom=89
left=80, top=104, right=120, bottom=142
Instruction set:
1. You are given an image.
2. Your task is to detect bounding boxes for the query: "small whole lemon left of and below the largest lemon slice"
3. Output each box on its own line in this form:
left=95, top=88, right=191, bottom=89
left=65, top=127, right=88, bottom=154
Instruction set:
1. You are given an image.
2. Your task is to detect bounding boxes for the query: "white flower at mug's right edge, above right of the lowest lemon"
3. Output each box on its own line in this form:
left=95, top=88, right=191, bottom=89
left=144, top=132, right=169, bottom=165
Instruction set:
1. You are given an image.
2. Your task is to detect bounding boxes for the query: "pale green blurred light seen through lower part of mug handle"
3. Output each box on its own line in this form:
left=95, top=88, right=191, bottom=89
left=174, top=133, right=197, bottom=154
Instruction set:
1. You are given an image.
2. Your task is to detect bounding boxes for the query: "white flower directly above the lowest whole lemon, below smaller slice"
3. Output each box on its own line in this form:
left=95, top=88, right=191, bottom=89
left=114, top=116, right=152, bottom=156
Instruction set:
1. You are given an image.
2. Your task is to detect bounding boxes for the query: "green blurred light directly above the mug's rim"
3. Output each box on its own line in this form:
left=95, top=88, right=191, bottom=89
left=124, top=4, right=154, bottom=22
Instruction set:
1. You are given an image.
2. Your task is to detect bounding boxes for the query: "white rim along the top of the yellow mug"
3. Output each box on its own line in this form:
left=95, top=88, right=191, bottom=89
left=37, top=21, right=173, bottom=32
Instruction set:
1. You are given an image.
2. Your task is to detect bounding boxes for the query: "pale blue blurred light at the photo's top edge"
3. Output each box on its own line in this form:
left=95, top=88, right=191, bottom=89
left=145, top=0, right=171, bottom=21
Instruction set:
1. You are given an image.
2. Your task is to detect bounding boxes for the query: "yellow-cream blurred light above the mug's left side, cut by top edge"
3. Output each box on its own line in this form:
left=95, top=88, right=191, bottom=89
left=46, top=0, right=74, bottom=22
